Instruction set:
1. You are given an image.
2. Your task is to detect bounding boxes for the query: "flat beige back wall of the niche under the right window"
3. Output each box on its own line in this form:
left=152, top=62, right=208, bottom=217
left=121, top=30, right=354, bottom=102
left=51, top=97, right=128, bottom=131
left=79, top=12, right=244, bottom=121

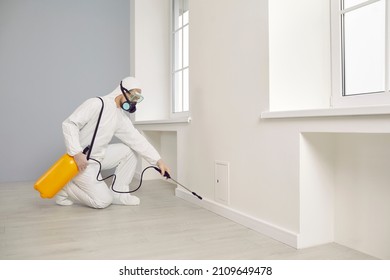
left=335, top=133, right=390, bottom=259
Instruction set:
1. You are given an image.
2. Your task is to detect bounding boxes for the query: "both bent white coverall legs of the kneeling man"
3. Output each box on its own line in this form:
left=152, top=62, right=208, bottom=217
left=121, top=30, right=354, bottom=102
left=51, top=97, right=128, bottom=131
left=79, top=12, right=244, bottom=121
left=62, top=143, right=140, bottom=208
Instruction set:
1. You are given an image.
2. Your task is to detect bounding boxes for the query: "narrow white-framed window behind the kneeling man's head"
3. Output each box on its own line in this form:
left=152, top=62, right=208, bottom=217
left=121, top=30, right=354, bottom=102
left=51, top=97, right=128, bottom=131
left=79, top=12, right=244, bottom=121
left=172, top=0, right=189, bottom=114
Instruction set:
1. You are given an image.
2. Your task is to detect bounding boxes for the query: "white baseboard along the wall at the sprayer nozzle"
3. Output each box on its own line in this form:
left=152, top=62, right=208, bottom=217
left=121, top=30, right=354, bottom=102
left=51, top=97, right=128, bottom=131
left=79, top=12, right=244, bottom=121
left=175, top=188, right=298, bottom=248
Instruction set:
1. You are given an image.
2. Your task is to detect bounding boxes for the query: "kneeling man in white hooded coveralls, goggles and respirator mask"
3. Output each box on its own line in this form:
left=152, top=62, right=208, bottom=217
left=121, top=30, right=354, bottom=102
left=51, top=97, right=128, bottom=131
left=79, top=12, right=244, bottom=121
left=56, top=77, right=170, bottom=208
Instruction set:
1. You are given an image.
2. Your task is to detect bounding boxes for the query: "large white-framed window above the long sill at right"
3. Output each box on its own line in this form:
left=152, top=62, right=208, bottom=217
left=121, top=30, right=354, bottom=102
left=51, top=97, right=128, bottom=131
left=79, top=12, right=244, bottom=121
left=332, top=0, right=390, bottom=106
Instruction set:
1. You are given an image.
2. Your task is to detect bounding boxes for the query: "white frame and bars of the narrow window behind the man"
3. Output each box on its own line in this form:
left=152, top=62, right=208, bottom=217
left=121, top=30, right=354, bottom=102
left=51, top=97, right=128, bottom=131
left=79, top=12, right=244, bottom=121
left=170, top=0, right=190, bottom=119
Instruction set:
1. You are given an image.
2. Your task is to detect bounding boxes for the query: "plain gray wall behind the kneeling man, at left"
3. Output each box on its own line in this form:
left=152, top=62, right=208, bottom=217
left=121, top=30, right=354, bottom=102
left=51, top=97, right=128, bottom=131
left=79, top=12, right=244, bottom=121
left=0, top=0, right=130, bottom=182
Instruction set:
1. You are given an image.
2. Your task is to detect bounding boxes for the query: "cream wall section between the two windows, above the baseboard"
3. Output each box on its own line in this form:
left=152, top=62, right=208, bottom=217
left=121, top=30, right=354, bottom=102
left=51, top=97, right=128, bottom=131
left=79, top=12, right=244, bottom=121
left=183, top=0, right=299, bottom=231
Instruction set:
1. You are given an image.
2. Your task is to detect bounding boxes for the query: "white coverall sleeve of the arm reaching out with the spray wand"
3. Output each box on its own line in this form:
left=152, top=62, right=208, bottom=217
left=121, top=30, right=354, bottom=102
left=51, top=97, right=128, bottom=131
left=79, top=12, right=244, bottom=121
left=115, top=117, right=161, bottom=165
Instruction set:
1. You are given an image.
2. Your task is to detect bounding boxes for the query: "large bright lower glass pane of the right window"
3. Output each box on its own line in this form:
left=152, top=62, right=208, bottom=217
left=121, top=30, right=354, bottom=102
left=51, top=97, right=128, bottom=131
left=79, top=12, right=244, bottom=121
left=343, top=0, right=386, bottom=95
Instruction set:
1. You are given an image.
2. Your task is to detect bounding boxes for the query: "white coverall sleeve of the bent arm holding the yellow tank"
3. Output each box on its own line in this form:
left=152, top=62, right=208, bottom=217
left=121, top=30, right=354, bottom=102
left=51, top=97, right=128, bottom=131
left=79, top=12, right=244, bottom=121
left=62, top=98, right=100, bottom=156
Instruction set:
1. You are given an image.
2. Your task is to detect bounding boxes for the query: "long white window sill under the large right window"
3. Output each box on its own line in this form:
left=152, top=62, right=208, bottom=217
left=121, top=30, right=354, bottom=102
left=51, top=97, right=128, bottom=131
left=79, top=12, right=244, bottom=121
left=261, top=106, right=390, bottom=119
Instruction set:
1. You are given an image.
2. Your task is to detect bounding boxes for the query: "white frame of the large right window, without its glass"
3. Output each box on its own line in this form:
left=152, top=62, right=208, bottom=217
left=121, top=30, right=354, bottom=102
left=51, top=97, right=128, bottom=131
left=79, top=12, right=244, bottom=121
left=330, top=0, right=390, bottom=107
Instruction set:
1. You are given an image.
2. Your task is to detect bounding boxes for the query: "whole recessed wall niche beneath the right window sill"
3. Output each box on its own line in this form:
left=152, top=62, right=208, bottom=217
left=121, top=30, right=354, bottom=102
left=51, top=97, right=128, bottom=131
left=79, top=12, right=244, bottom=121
left=298, top=132, right=390, bottom=259
